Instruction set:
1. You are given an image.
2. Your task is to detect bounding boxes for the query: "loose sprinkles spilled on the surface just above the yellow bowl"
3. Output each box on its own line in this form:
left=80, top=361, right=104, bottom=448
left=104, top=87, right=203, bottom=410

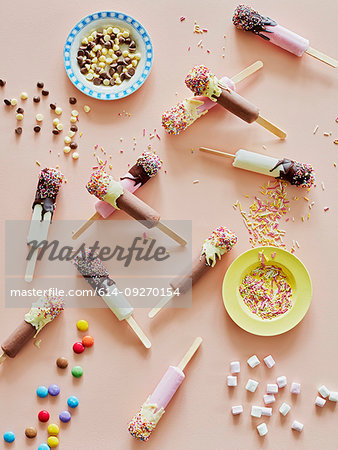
left=234, top=180, right=290, bottom=247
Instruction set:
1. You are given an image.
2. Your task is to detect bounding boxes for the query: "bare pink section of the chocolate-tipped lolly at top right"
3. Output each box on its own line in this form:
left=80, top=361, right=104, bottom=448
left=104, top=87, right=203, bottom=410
left=261, top=25, right=310, bottom=56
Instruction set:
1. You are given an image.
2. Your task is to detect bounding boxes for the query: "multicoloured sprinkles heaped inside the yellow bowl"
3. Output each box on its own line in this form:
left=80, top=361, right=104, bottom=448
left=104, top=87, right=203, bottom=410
left=239, top=264, right=292, bottom=320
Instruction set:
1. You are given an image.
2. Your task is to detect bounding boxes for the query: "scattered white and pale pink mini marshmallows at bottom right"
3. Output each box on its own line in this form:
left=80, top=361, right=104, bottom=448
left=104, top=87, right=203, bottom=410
left=227, top=355, right=304, bottom=436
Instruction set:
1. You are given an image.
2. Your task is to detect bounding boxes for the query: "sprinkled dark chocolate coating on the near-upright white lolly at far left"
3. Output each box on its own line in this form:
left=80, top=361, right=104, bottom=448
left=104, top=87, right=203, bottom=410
left=32, top=168, right=65, bottom=220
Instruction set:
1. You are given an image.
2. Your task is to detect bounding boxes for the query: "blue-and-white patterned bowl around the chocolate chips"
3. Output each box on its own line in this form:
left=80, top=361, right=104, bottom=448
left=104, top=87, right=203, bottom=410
left=63, top=11, right=153, bottom=100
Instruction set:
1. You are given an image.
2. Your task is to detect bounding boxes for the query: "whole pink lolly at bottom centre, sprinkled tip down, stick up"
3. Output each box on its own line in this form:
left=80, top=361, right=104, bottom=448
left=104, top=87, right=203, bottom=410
left=128, top=337, right=202, bottom=441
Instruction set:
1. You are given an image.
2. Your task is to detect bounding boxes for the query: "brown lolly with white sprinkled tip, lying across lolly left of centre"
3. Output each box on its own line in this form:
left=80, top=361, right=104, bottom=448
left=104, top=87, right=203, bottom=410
left=87, top=170, right=187, bottom=245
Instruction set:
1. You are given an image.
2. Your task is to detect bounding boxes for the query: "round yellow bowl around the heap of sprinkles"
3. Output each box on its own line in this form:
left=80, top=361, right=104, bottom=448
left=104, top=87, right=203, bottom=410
left=222, top=247, right=312, bottom=336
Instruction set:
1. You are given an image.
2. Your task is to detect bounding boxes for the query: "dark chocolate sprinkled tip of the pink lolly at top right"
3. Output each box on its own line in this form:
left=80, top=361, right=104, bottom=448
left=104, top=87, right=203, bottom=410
left=232, top=5, right=277, bottom=40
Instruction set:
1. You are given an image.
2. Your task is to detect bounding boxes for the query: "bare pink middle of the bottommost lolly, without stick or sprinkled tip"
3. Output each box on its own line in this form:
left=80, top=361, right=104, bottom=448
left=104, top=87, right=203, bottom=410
left=149, top=366, right=185, bottom=410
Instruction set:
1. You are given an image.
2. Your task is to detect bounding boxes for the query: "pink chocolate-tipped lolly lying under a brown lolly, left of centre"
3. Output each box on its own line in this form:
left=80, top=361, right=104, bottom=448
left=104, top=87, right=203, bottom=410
left=73, top=152, right=162, bottom=239
